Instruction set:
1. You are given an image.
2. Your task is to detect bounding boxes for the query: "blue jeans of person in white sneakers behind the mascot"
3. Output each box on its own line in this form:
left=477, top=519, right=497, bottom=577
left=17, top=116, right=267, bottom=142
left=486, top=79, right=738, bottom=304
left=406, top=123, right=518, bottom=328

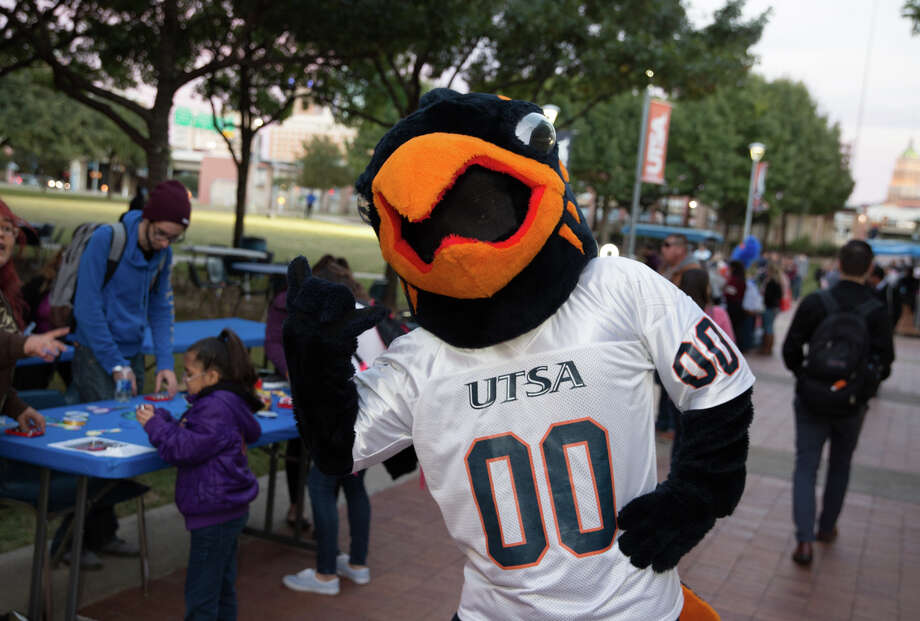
left=307, top=468, right=371, bottom=575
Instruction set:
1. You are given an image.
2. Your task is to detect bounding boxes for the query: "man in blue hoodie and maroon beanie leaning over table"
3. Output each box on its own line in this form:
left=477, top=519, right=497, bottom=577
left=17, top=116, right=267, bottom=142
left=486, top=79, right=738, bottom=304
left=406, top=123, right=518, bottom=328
left=73, top=181, right=191, bottom=403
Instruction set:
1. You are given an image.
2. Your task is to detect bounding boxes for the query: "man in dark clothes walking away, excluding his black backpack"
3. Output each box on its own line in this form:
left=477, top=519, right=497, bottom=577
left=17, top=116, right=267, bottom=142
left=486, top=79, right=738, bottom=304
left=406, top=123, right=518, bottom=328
left=783, top=240, right=894, bottom=565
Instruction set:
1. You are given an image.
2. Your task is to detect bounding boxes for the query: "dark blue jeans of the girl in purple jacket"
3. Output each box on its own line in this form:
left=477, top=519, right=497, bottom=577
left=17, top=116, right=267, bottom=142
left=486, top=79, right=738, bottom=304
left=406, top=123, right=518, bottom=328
left=185, top=511, right=249, bottom=621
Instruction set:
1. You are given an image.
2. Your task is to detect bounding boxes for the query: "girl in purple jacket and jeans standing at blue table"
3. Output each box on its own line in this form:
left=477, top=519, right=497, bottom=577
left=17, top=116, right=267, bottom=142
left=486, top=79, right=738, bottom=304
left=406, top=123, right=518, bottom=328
left=137, top=330, right=262, bottom=621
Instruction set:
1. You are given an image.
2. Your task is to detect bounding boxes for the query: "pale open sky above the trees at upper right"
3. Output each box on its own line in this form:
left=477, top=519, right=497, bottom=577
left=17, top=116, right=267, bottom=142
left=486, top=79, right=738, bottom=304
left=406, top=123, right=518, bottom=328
left=687, top=0, right=920, bottom=204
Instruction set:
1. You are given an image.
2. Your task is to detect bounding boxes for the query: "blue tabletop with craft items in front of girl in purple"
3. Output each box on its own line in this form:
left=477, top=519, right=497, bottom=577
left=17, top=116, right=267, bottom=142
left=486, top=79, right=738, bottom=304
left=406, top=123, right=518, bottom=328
left=0, top=393, right=298, bottom=479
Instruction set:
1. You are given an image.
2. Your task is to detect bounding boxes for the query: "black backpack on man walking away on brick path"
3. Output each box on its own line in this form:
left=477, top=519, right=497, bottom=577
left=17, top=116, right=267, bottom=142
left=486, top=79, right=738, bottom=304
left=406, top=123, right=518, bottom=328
left=796, top=290, right=882, bottom=416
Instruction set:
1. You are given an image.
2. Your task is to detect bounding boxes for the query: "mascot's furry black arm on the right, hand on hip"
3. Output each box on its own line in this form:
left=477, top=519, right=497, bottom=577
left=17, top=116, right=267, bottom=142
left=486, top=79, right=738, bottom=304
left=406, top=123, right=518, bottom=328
left=617, top=389, right=754, bottom=572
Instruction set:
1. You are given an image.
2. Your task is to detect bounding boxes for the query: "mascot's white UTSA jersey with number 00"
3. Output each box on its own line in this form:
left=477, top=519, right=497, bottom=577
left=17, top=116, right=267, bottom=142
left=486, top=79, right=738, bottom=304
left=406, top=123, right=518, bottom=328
left=353, top=258, right=754, bottom=621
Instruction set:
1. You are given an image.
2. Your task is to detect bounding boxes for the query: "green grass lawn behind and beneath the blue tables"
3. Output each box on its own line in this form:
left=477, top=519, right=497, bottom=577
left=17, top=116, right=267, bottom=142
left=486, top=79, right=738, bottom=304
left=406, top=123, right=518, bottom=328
left=0, top=190, right=384, bottom=553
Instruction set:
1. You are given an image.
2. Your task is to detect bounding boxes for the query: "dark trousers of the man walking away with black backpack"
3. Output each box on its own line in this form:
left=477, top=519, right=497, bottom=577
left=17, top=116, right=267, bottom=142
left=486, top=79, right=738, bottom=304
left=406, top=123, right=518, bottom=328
left=792, top=398, right=866, bottom=542
